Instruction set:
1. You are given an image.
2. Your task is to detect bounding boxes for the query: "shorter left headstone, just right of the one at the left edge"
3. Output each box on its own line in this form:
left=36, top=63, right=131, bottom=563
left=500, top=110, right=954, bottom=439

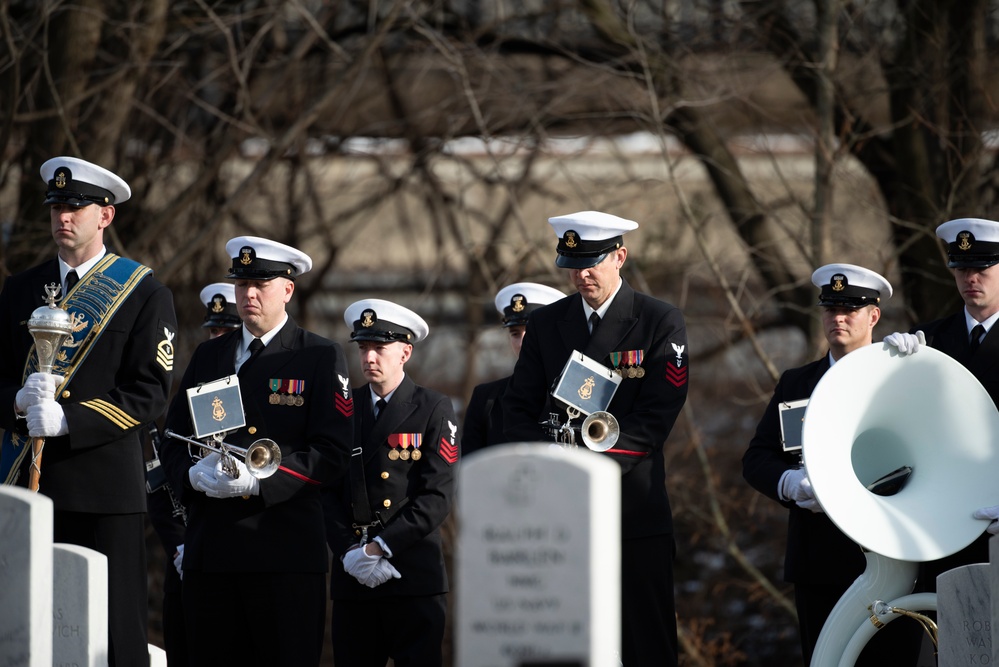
left=52, top=544, right=108, bottom=667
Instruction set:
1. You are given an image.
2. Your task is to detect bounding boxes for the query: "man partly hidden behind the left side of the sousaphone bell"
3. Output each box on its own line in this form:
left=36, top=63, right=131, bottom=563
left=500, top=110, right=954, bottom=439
left=742, top=263, right=919, bottom=666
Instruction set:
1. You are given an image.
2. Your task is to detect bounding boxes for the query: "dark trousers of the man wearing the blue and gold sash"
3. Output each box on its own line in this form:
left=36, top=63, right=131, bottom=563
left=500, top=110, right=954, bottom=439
left=53, top=511, right=149, bottom=667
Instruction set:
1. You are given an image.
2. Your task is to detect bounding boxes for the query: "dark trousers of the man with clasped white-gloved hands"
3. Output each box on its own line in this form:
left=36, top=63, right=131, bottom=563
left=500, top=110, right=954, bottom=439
left=330, top=594, right=446, bottom=667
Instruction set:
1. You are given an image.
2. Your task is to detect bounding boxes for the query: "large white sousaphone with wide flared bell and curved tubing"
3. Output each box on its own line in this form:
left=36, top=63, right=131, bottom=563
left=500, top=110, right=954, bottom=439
left=802, top=344, right=999, bottom=667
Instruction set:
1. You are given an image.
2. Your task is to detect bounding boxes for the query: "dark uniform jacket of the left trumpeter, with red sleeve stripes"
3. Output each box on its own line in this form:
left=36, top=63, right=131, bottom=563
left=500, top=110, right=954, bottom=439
left=160, top=317, right=354, bottom=572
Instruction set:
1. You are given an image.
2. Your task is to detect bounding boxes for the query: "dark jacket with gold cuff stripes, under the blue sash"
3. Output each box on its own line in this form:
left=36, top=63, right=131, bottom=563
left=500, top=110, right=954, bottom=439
left=0, top=258, right=177, bottom=514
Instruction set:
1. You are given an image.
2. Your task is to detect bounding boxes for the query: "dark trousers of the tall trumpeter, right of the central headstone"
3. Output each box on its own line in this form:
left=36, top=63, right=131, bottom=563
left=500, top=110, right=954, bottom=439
left=621, top=535, right=677, bottom=667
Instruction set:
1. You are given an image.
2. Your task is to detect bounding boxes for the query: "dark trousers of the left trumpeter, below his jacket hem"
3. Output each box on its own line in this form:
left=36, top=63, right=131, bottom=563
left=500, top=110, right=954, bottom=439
left=182, top=570, right=326, bottom=667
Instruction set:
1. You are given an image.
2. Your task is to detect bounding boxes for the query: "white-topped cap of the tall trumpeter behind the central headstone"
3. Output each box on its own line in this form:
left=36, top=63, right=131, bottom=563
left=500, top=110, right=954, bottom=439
left=548, top=211, right=638, bottom=269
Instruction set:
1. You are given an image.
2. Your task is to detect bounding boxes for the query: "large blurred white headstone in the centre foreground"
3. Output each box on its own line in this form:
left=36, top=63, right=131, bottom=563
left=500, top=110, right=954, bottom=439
left=455, top=443, right=621, bottom=667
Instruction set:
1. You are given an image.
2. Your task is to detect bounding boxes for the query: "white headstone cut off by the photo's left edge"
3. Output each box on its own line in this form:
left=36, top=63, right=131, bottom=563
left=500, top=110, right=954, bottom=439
left=0, top=486, right=53, bottom=667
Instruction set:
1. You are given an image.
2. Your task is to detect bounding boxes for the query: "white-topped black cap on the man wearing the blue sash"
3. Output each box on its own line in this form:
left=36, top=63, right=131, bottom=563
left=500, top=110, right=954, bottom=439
left=39, top=156, right=132, bottom=208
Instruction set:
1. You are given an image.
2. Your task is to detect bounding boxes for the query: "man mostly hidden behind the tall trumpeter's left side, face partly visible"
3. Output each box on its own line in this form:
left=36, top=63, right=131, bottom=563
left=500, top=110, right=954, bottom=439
left=461, top=282, right=565, bottom=456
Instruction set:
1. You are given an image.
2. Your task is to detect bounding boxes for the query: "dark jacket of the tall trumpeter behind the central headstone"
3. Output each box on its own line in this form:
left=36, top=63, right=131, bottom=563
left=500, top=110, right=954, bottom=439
left=503, top=279, right=689, bottom=538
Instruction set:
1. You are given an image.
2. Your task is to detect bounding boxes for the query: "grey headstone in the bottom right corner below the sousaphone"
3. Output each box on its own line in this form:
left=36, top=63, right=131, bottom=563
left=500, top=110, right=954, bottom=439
left=937, top=563, right=992, bottom=667
